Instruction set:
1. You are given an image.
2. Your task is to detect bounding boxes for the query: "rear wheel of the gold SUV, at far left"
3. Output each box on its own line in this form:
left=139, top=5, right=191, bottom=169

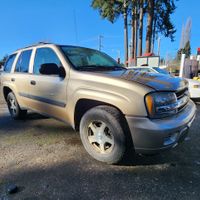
left=7, top=92, right=27, bottom=120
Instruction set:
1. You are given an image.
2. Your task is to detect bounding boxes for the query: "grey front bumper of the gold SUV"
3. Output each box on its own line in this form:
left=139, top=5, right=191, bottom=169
left=126, top=100, right=196, bottom=154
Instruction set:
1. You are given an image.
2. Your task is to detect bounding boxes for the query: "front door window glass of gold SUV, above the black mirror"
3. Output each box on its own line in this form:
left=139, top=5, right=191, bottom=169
left=33, top=48, right=62, bottom=75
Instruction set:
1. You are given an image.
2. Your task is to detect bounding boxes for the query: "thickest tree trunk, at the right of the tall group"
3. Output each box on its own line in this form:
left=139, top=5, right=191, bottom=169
left=146, top=0, right=154, bottom=53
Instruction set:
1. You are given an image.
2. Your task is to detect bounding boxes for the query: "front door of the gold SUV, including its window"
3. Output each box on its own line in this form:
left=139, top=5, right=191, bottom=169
left=29, top=47, right=67, bottom=118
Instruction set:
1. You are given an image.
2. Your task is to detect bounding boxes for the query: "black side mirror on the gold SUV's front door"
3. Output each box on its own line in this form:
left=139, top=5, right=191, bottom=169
left=40, top=63, right=60, bottom=75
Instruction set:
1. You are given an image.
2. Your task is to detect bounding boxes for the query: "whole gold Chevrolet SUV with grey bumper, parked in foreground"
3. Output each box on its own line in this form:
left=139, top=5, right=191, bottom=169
left=2, top=43, right=196, bottom=163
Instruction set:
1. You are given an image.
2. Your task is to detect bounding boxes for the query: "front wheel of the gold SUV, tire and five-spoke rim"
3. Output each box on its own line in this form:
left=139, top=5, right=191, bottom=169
left=80, top=106, right=126, bottom=164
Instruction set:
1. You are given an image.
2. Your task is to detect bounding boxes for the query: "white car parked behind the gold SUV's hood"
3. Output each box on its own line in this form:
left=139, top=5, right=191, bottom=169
left=131, top=66, right=200, bottom=100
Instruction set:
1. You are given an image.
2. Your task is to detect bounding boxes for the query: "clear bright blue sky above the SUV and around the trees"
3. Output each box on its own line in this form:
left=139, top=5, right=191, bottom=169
left=0, top=0, right=200, bottom=61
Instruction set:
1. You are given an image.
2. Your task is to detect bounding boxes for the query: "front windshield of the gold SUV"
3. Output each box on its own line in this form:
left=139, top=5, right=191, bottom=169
left=60, top=46, right=124, bottom=70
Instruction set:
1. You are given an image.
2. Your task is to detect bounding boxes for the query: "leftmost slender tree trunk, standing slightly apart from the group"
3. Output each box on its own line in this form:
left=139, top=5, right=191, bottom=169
left=123, top=0, right=128, bottom=66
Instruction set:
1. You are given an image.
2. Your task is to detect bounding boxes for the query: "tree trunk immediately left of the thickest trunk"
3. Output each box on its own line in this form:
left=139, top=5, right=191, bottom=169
left=138, top=0, right=144, bottom=56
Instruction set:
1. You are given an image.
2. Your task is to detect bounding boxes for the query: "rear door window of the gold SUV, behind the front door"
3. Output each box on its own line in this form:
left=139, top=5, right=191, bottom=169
left=15, top=50, right=32, bottom=73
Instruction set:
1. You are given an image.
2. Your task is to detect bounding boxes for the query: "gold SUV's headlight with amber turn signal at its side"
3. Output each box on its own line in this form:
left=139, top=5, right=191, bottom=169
left=145, top=92, right=178, bottom=118
